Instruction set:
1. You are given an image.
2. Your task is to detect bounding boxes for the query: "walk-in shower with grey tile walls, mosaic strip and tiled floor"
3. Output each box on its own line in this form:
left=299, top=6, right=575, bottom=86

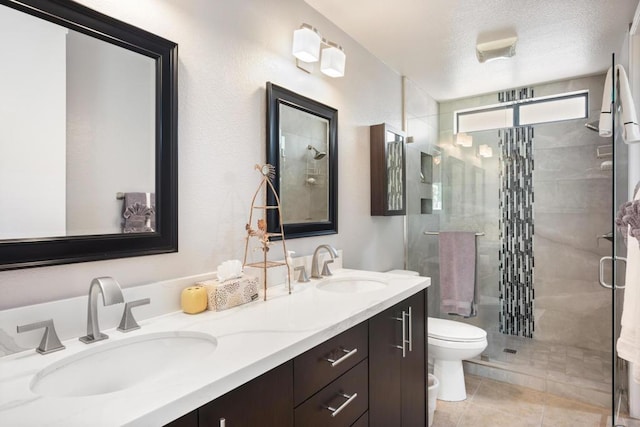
left=407, top=75, right=626, bottom=418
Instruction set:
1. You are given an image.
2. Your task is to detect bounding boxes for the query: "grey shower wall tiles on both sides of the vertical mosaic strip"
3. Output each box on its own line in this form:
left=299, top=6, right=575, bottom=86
left=407, top=75, right=611, bottom=350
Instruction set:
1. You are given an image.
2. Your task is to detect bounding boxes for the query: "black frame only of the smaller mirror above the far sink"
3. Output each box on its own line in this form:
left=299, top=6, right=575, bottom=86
left=267, top=82, right=338, bottom=239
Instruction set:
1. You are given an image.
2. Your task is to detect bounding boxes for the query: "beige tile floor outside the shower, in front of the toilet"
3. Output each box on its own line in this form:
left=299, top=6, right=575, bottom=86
left=433, top=374, right=640, bottom=427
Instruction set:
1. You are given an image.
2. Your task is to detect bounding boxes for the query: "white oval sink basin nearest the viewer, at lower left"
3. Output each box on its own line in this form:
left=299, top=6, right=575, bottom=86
left=31, top=331, right=218, bottom=397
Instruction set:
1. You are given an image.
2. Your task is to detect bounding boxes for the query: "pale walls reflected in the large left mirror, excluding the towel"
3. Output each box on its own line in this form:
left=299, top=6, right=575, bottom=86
left=0, top=7, right=155, bottom=239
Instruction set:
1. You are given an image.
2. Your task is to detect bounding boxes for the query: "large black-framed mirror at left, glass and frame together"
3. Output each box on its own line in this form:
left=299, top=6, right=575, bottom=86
left=0, top=0, right=177, bottom=270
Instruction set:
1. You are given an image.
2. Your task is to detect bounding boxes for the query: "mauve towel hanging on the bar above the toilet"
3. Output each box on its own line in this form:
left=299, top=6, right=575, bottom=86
left=439, top=231, right=478, bottom=317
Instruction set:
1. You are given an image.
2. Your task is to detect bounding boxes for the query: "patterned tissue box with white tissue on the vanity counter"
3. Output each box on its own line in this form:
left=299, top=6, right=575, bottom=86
left=197, top=275, right=258, bottom=311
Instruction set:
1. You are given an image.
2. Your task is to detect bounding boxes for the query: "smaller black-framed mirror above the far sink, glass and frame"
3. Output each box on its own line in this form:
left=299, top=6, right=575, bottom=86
left=267, top=82, right=338, bottom=239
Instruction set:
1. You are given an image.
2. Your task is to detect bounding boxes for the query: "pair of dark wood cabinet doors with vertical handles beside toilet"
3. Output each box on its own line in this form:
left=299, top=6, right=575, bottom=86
left=369, top=291, right=427, bottom=427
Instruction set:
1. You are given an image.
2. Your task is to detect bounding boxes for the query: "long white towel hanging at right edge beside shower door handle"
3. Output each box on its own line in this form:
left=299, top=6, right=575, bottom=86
left=616, top=186, right=640, bottom=382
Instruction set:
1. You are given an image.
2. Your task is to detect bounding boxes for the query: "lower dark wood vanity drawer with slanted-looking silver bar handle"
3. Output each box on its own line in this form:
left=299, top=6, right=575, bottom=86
left=295, top=359, right=369, bottom=427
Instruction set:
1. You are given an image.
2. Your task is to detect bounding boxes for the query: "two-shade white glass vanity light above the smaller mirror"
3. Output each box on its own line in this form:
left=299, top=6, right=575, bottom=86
left=291, top=24, right=347, bottom=77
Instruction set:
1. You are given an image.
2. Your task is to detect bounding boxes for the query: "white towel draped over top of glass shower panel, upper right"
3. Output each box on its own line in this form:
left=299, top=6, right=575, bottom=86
left=598, top=65, right=640, bottom=144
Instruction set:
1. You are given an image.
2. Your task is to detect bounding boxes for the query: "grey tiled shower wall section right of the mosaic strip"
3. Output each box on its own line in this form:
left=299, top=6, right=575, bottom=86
left=534, top=76, right=612, bottom=350
